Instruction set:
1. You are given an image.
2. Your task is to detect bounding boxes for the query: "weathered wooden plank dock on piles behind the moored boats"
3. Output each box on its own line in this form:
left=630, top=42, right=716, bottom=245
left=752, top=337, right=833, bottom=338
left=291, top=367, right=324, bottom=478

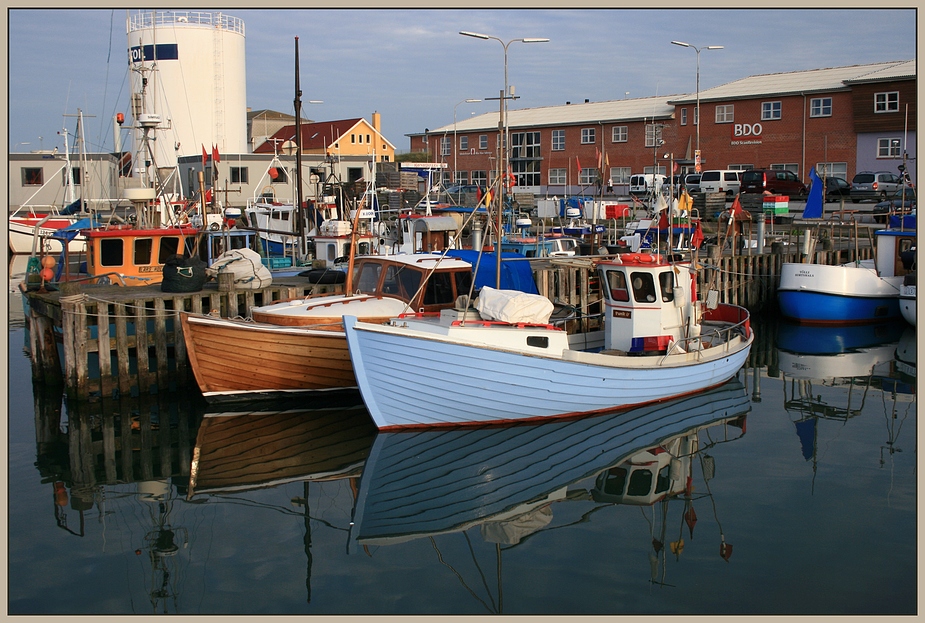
left=19, top=245, right=872, bottom=400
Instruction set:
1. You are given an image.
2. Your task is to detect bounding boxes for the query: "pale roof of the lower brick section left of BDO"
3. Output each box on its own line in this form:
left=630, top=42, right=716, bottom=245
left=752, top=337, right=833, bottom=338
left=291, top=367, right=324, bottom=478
left=422, top=96, right=677, bottom=136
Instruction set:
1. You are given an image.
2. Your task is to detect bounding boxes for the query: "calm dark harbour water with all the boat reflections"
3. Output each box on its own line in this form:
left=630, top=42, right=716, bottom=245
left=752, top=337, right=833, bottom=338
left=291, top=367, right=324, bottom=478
left=8, top=319, right=918, bottom=615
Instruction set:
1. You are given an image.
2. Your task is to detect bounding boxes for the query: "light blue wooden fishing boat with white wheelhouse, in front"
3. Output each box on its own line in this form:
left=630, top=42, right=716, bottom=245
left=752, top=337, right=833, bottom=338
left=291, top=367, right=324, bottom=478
left=344, top=253, right=754, bottom=430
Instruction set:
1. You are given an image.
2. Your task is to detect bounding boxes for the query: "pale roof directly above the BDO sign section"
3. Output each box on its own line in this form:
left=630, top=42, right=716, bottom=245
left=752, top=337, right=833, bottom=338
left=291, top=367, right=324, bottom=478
left=669, top=61, right=915, bottom=105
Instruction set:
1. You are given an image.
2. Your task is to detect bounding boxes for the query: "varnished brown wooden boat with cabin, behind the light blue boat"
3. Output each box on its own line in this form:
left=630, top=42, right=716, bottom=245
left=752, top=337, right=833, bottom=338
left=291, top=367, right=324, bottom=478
left=180, top=254, right=472, bottom=402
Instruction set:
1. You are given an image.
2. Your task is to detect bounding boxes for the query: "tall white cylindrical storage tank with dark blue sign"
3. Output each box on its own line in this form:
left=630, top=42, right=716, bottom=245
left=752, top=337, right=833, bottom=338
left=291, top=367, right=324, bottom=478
left=126, top=11, right=247, bottom=169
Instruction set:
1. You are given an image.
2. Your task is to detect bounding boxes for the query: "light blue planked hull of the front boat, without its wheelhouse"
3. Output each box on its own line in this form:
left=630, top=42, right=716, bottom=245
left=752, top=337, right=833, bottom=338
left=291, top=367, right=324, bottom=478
left=344, top=316, right=754, bottom=430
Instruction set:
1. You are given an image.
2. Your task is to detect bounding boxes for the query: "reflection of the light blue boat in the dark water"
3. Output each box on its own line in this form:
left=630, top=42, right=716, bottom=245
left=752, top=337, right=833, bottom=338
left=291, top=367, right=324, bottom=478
left=348, top=378, right=751, bottom=604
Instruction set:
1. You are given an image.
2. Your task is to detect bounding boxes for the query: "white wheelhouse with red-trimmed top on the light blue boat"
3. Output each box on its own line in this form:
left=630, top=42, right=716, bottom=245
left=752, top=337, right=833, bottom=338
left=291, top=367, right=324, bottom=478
left=598, top=253, right=694, bottom=354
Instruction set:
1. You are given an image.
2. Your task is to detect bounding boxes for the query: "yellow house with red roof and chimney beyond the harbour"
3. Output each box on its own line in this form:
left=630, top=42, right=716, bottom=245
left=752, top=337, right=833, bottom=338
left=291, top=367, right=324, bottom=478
left=254, top=112, right=395, bottom=162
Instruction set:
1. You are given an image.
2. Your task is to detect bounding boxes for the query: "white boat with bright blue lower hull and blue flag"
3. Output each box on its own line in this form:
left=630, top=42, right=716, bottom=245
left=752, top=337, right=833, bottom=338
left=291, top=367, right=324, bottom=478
left=777, top=170, right=916, bottom=324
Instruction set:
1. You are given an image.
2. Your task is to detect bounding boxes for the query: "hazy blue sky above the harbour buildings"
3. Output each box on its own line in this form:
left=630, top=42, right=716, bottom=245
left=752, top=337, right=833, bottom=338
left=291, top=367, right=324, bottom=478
left=7, top=8, right=916, bottom=152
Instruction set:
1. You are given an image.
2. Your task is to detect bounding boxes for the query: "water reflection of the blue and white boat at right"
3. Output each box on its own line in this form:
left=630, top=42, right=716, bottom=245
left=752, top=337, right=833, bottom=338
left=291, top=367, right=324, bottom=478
left=777, top=319, right=915, bottom=474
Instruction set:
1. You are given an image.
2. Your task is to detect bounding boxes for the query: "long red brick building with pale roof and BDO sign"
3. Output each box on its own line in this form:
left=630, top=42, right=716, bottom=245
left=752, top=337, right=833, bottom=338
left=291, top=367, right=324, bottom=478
left=410, top=61, right=916, bottom=196
